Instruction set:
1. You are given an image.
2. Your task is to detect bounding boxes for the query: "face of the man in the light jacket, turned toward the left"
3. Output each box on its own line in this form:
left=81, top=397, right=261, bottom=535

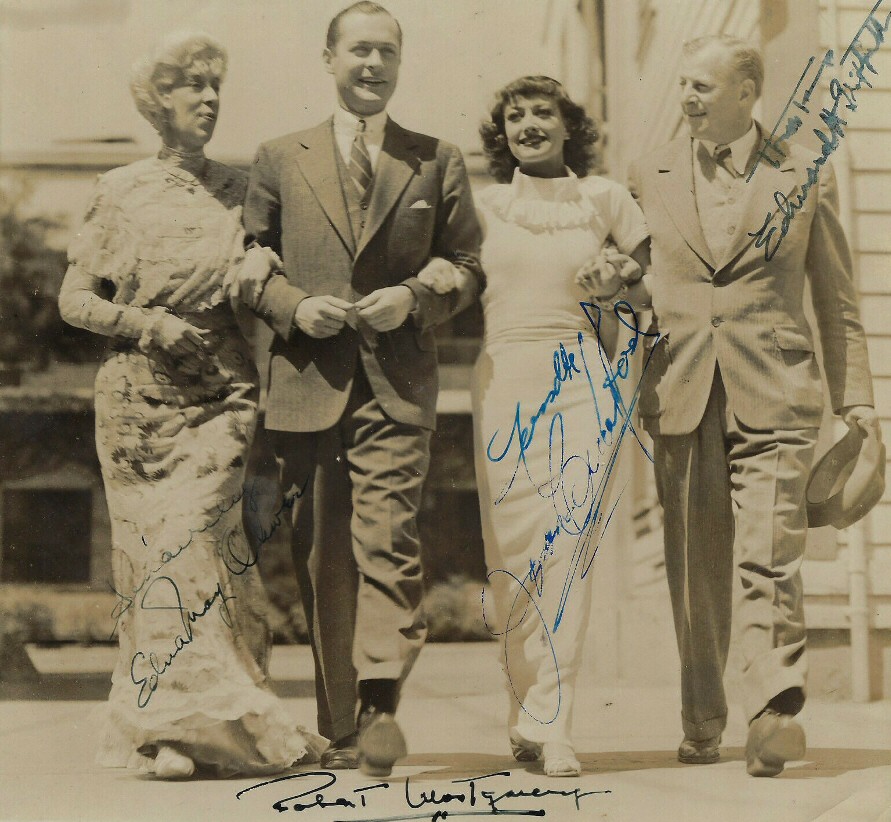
left=680, top=45, right=755, bottom=143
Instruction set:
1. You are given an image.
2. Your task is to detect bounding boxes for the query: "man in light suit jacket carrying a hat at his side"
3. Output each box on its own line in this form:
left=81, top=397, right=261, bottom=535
left=630, top=37, right=877, bottom=776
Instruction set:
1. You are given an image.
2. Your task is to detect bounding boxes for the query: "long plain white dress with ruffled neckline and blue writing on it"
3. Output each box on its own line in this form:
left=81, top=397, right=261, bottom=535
left=473, top=170, right=647, bottom=744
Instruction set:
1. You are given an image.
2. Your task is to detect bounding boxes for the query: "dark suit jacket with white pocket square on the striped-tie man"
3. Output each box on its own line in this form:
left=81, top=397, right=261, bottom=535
left=244, top=120, right=482, bottom=438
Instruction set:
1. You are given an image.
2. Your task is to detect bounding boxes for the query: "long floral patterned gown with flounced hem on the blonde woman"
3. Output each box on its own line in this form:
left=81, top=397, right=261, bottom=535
left=60, top=151, right=323, bottom=776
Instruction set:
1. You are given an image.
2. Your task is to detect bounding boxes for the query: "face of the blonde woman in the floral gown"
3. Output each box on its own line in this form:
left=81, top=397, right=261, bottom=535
left=159, top=67, right=220, bottom=151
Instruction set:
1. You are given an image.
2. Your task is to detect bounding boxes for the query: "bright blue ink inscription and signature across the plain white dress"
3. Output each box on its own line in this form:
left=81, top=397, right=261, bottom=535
left=482, top=301, right=660, bottom=724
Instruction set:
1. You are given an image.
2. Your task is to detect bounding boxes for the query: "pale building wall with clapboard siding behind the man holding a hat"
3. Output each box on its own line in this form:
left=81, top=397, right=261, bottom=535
left=604, top=0, right=891, bottom=695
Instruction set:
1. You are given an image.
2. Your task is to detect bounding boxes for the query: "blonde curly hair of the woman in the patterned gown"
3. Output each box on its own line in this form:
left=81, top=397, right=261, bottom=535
left=130, top=32, right=229, bottom=134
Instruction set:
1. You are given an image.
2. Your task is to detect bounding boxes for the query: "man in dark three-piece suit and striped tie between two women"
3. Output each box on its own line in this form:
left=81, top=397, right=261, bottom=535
left=244, top=2, right=482, bottom=776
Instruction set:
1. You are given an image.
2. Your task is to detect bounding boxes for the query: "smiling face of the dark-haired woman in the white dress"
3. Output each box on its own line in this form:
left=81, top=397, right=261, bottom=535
left=504, top=96, right=567, bottom=177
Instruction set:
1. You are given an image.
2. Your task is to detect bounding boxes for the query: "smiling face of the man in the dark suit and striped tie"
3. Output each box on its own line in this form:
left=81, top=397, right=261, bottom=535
left=324, top=12, right=402, bottom=117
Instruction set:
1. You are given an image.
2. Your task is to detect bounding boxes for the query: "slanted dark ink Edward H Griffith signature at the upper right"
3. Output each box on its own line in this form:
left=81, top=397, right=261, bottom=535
left=746, top=0, right=891, bottom=262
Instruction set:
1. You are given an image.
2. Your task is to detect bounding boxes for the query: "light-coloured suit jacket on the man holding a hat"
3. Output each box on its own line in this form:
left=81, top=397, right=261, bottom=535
left=629, top=130, right=873, bottom=435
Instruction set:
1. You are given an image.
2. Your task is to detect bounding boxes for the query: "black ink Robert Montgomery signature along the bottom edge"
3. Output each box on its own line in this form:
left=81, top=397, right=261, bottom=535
left=235, top=771, right=612, bottom=822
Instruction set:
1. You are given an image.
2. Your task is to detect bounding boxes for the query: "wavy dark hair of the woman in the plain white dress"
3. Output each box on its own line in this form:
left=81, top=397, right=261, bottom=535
left=480, top=75, right=599, bottom=183
